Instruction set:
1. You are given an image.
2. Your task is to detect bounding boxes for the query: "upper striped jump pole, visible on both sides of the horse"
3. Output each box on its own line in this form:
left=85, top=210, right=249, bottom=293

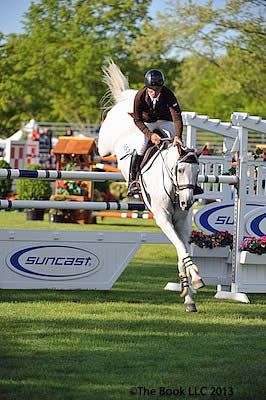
left=0, top=169, right=238, bottom=185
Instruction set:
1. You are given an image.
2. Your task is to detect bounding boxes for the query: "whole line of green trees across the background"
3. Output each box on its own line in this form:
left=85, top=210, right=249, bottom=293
left=0, top=0, right=266, bottom=137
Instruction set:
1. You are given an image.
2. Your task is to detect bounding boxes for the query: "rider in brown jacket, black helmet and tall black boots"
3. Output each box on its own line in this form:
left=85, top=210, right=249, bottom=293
left=128, top=69, right=183, bottom=195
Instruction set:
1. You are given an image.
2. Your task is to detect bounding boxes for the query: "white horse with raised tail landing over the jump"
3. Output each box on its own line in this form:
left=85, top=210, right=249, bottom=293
left=98, top=60, right=204, bottom=312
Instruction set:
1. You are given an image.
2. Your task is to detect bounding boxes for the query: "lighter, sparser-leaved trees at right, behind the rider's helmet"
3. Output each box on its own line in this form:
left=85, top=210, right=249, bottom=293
left=129, top=0, right=266, bottom=120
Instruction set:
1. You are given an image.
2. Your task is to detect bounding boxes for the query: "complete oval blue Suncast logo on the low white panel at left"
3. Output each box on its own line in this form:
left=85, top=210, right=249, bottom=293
left=6, top=245, right=100, bottom=280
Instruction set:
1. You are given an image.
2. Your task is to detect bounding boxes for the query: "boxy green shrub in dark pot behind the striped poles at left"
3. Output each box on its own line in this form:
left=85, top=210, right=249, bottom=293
left=17, top=164, right=51, bottom=220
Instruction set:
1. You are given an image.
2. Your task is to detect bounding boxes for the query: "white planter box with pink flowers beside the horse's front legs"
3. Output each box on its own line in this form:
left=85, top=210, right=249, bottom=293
left=189, top=231, right=233, bottom=285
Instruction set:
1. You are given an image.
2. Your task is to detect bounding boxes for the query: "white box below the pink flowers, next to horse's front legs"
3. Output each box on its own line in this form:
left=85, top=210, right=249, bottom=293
left=191, top=245, right=232, bottom=285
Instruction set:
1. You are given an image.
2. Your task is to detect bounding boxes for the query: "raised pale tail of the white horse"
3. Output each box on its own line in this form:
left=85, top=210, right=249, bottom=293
left=103, top=59, right=129, bottom=103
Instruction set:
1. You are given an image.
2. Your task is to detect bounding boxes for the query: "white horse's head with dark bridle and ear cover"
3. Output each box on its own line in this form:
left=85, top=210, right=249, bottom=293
left=172, top=145, right=200, bottom=211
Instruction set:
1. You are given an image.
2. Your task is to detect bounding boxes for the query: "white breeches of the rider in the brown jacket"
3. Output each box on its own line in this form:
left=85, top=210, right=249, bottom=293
left=134, top=119, right=175, bottom=156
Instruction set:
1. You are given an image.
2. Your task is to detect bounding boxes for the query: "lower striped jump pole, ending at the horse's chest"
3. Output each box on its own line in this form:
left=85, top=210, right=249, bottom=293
left=0, top=200, right=147, bottom=211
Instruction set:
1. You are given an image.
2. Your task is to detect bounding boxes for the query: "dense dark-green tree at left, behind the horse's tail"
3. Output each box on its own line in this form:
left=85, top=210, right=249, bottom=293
left=0, top=0, right=151, bottom=135
